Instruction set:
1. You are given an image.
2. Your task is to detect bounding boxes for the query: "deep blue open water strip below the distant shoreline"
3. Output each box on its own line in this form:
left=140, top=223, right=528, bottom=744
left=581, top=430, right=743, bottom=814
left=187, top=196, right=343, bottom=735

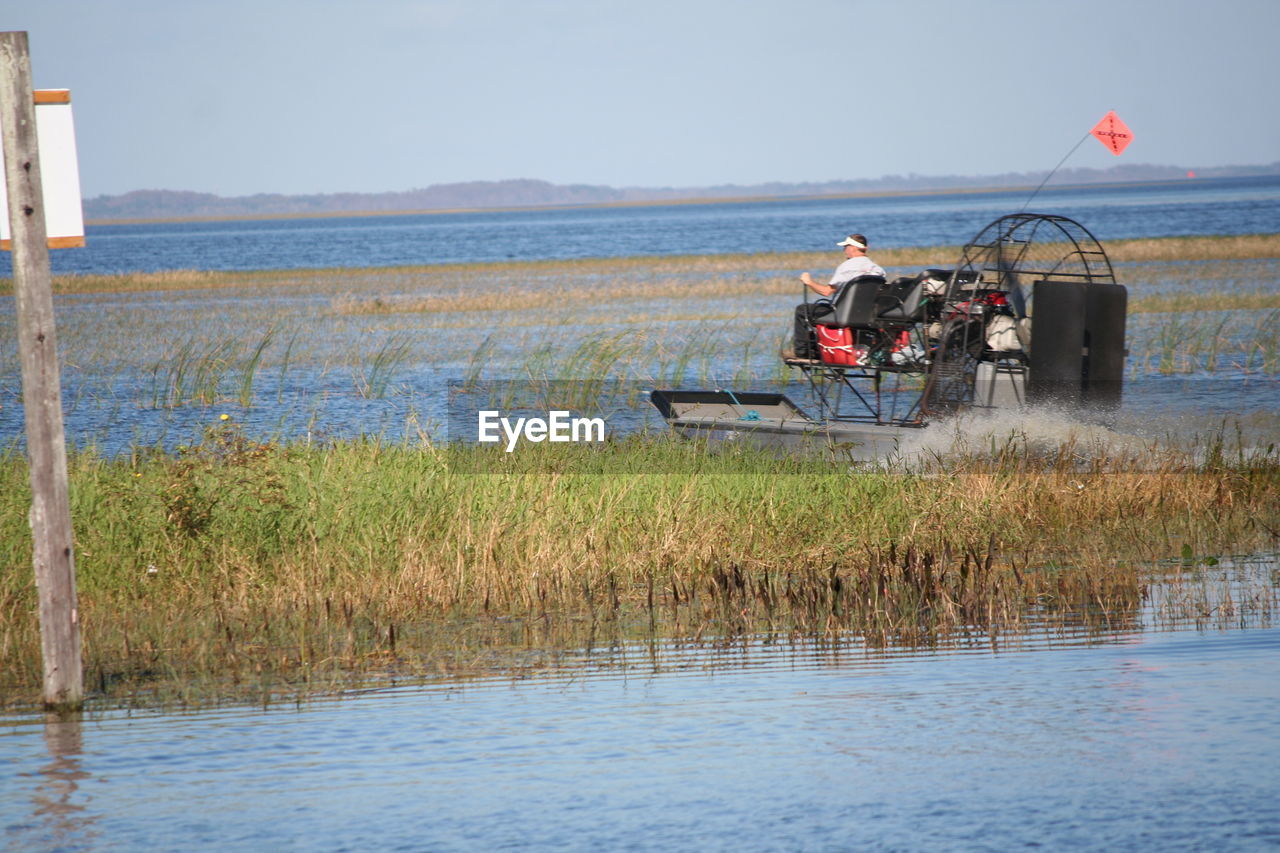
left=0, top=175, right=1280, bottom=275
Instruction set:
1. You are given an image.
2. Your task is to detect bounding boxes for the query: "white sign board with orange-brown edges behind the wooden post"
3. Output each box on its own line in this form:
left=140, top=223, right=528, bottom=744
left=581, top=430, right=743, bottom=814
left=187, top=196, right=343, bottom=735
left=0, top=88, right=84, bottom=250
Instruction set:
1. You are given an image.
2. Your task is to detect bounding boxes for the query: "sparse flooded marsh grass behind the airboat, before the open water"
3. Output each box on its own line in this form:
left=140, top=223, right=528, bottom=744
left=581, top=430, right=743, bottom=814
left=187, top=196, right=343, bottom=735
left=0, top=234, right=1280, bottom=425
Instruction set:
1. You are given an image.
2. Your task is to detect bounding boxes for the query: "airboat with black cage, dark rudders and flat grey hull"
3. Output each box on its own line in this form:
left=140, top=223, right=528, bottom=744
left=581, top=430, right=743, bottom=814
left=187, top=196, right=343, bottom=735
left=650, top=213, right=1128, bottom=457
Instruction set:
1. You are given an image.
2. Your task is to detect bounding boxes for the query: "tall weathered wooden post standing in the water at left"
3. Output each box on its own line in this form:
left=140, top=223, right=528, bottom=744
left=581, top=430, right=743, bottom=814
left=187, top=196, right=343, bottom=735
left=0, top=32, right=84, bottom=708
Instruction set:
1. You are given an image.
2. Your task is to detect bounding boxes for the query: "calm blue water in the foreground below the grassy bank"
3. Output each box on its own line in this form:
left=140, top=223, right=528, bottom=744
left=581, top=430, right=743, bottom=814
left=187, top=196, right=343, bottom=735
left=0, top=561, right=1280, bottom=850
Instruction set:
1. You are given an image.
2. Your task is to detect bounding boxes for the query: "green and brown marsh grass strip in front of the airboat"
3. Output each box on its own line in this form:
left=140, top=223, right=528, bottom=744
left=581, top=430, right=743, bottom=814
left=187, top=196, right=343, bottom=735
left=0, top=425, right=1280, bottom=703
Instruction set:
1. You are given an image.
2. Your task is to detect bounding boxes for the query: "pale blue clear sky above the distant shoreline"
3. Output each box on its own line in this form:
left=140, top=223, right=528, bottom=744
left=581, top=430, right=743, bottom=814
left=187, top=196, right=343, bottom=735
left=10, top=0, right=1280, bottom=197
